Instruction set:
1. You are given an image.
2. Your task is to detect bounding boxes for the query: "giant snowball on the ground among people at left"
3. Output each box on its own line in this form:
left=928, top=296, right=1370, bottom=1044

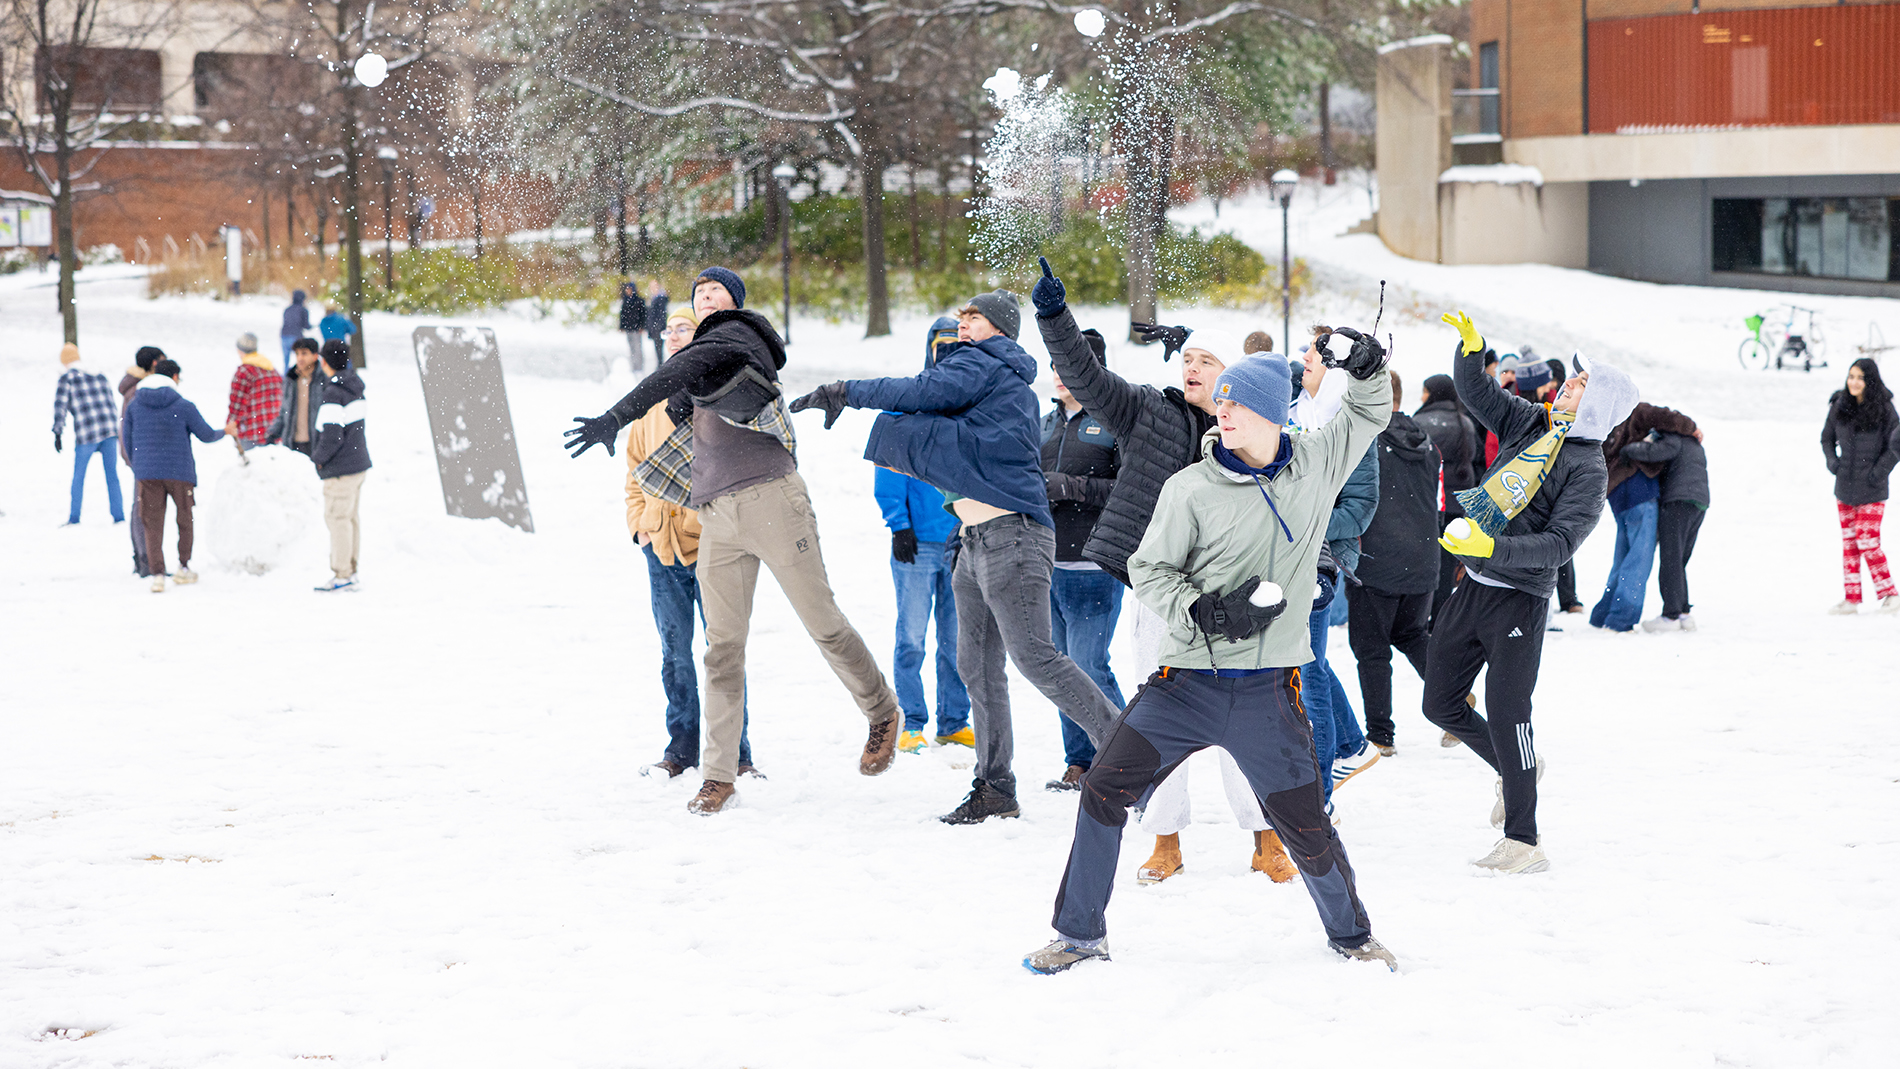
left=211, top=446, right=323, bottom=575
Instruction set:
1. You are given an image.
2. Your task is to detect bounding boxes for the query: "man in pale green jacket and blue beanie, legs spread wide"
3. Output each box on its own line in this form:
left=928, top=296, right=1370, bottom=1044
left=1022, top=328, right=1397, bottom=974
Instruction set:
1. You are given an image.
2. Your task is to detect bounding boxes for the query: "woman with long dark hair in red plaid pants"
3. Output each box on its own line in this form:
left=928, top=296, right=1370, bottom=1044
left=1820, top=357, right=1900, bottom=615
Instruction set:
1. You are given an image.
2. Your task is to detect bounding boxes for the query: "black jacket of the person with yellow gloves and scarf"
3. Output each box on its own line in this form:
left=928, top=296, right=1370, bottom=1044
left=1452, top=342, right=1609, bottom=598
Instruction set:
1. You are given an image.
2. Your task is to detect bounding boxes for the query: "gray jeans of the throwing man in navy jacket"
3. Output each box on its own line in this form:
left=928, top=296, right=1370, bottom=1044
left=952, top=515, right=1121, bottom=794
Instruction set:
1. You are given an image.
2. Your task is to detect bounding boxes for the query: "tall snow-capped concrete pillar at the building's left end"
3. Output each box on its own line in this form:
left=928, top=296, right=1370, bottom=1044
left=1378, top=34, right=1454, bottom=262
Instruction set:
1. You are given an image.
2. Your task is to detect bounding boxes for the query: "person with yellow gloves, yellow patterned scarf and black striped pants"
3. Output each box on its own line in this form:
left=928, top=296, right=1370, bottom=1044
left=1423, top=311, right=1638, bottom=873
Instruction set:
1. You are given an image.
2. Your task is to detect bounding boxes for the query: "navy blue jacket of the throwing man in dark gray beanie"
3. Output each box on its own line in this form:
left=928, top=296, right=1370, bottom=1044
left=846, top=334, right=1056, bottom=530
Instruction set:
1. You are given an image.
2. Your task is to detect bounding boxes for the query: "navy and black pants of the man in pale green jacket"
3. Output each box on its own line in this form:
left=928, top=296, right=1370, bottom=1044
left=1055, top=668, right=1372, bottom=946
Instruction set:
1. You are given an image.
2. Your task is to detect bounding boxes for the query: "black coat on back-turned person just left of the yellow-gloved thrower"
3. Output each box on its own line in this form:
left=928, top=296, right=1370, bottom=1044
left=1357, top=412, right=1444, bottom=594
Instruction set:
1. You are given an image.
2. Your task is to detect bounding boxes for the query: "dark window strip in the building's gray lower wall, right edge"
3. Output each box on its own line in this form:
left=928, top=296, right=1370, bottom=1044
left=1710, top=197, right=1900, bottom=281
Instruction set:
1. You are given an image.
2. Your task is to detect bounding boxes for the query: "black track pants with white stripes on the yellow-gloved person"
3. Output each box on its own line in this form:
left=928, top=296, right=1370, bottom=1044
left=1425, top=579, right=1549, bottom=845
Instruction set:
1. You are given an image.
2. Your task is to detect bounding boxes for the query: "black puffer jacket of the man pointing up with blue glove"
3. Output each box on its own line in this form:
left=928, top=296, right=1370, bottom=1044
left=1036, top=308, right=1214, bottom=585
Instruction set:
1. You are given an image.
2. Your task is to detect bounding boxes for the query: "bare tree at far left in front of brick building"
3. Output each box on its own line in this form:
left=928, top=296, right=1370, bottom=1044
left=0, top=0, right=177, bottom=344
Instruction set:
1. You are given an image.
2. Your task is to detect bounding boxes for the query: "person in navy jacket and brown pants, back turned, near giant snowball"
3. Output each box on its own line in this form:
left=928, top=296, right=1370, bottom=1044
left=120, top=359, right=236, bottom=594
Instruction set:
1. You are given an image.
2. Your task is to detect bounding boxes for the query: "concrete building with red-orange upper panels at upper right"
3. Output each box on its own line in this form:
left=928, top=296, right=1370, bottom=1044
left=1379, top=0, right=1900, bottom=296
